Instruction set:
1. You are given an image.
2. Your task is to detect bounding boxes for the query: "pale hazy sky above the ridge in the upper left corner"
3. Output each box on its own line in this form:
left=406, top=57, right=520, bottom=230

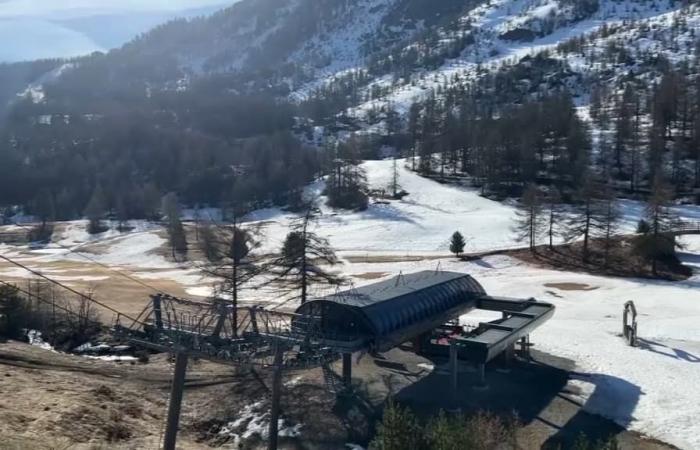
left=0, top=0, right=231, bottom=62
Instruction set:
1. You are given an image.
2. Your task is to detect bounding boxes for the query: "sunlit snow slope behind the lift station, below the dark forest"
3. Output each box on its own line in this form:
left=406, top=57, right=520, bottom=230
left=249, top=160, right=516, bottom=256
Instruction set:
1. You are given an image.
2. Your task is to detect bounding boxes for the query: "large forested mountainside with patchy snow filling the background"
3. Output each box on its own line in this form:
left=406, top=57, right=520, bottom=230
left=0, top=0, right=700, bottom=224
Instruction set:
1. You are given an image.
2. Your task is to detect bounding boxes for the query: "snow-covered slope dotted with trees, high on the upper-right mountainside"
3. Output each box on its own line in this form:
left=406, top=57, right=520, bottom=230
left=340, top=0, right=688, bottom=118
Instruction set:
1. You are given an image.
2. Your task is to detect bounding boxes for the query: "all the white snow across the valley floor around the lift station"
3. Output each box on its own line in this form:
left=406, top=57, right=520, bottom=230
left=0, top=161, right=700, bottom=449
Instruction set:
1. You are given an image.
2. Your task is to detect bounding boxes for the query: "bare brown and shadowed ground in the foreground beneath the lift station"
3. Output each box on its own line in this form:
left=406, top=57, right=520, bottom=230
left=0, top=342, right=671, bottom=450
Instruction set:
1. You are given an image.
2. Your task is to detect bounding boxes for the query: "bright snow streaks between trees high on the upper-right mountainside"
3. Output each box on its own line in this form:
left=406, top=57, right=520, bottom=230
left=347, top=0, right=684, bottom=118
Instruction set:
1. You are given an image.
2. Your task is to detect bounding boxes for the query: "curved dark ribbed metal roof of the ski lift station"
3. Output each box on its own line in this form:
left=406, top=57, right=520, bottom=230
left=297, top=271, right=486, bottom=338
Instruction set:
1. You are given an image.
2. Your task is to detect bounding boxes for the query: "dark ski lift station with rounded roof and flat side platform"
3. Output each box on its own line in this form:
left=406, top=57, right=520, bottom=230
left=296, top=271, right=554, bottom=379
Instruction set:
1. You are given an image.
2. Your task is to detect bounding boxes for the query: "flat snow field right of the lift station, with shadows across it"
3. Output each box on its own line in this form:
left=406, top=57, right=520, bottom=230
left=334, top=236, right=700, bottom=449
